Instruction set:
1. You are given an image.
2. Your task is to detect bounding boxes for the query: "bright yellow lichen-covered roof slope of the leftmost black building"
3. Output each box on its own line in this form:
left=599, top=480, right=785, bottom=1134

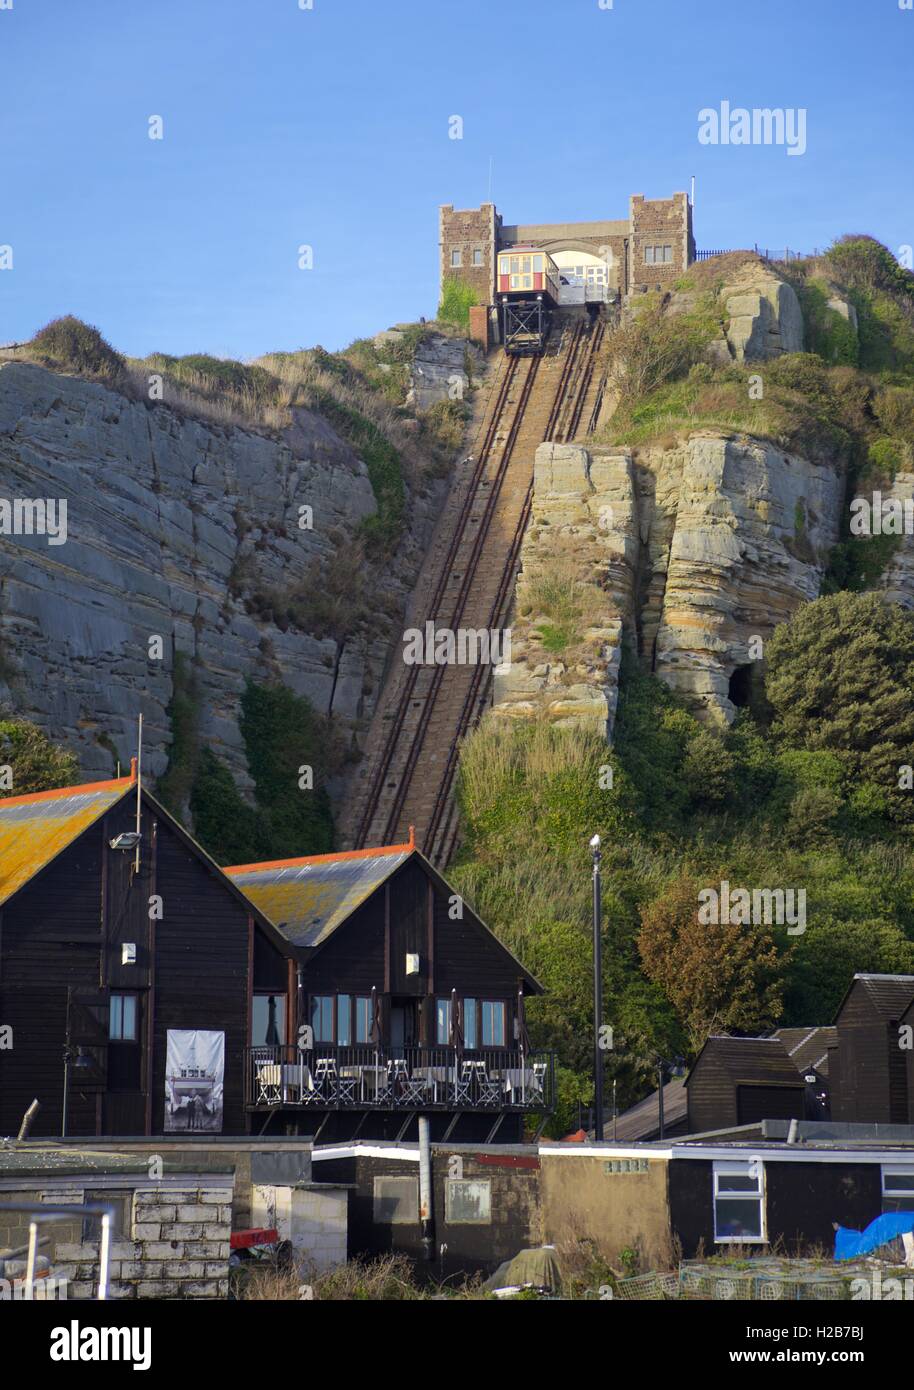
left=0, top=777, right=136, bottom=905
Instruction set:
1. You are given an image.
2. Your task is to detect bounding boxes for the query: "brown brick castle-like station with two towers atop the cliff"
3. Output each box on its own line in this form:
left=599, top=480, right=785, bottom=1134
left=440, top=193, right=695, bottom=304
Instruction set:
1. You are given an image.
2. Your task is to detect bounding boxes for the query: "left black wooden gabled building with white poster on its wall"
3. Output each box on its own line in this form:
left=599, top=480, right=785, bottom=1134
left=0, top=777, right=293, bottom=1136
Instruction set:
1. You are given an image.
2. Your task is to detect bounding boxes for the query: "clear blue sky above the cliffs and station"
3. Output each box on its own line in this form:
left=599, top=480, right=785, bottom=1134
left=0, top=0, right=914, bottom=359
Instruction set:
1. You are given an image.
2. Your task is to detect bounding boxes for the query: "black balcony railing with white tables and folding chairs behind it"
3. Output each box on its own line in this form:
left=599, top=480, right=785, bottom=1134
left=244, top=1044, right=556, bottom=1115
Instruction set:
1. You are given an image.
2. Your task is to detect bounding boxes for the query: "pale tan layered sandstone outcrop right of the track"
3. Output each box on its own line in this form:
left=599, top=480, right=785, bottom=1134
left=495, top=434, right=845, bottom=733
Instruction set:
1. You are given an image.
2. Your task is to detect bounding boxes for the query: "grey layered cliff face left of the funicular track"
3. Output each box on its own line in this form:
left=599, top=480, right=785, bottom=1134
left=0, top=363, right=444, bottom=787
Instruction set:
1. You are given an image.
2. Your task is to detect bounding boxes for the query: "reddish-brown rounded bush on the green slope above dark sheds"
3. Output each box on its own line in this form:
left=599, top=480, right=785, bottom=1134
left=638, top=876, right=782, bottom=1047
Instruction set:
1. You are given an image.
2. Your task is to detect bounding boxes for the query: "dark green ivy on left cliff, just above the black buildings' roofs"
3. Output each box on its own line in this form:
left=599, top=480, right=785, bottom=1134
left=158, top=657, right=342, bottom=865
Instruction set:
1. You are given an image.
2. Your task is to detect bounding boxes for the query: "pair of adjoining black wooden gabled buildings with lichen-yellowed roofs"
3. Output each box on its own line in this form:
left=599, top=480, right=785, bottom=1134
left=0, top=777, right=554, bottom=1140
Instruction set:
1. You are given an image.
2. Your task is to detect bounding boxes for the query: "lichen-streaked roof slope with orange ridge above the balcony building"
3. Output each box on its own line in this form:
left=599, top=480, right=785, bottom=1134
left=225, top=840, right=415, bottom=947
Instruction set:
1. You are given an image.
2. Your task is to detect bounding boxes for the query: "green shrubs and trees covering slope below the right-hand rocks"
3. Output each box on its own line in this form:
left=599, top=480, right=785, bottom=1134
left=453, top=594, right=914, bottom=1133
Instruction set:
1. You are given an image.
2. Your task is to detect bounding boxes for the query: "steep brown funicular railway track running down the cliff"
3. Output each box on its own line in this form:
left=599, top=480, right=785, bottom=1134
left=347, top=318, right=604, bottom=867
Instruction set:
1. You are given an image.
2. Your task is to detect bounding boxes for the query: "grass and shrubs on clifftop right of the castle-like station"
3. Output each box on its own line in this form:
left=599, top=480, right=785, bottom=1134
left=597, top=236, right=914, bottom=592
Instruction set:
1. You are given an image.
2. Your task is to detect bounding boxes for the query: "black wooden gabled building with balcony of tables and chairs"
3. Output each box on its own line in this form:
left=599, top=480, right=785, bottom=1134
left=226, top=838, right=554, bottom=1141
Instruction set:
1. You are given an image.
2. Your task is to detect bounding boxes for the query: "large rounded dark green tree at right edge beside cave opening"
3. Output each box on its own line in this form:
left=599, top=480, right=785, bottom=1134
left=765, top=592, right=914, bottom=820
